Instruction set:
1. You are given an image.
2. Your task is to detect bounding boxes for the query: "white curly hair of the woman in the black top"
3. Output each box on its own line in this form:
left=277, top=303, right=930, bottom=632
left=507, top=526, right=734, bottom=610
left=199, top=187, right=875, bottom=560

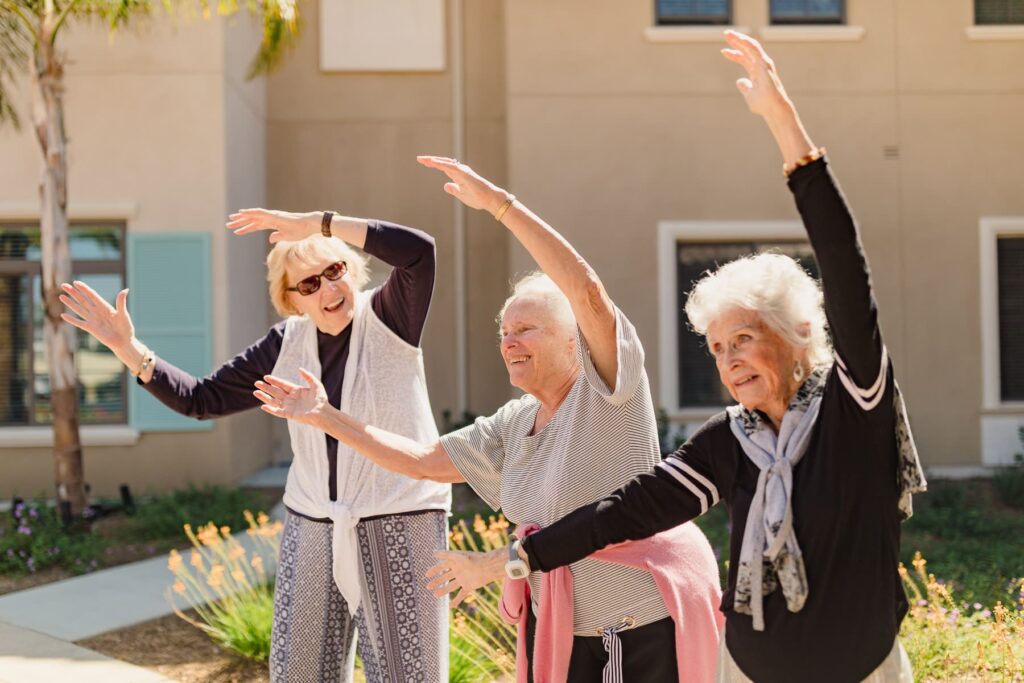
left=686, top=253, right=833, bottom=368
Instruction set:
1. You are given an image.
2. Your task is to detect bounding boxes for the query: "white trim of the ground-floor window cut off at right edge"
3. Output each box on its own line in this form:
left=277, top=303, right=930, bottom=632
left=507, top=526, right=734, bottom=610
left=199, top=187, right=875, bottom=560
left=979, top=216, right=1024, bottom=412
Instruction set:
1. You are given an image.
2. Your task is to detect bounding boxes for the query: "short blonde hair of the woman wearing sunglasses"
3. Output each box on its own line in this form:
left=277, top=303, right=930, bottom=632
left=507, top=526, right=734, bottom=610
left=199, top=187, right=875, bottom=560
left=266, top=234, right=370, bottom=317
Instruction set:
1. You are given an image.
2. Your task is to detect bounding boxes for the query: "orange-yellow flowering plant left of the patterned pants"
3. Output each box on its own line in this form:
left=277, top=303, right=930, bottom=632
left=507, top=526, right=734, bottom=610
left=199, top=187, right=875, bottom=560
left=167, top=510, right=283, bottom=660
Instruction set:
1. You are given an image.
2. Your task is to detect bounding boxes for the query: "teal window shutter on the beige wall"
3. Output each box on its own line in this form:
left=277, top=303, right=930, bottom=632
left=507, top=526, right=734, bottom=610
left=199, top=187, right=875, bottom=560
left=127, top=232, right=213, bottom=431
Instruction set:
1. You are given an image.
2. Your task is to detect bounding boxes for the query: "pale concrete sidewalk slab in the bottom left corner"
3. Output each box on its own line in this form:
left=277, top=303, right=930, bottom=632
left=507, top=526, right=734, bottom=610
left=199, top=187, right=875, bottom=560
left=0, top=624, right=173, bottom=683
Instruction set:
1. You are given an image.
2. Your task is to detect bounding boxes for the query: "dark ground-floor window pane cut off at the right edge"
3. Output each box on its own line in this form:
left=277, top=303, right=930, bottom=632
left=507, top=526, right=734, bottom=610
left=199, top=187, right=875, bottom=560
left=995, top=237, right=1024, bottom=401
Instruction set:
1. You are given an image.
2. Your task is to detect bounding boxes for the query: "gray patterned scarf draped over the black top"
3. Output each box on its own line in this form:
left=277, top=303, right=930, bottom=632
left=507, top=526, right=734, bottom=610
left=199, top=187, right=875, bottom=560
left=727, top=358, right=927, bottom=631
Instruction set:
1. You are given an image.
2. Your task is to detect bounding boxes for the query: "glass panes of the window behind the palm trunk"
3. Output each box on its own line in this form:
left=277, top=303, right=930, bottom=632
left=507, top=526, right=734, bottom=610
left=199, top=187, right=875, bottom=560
left=0, top=221, right=127, bottom=427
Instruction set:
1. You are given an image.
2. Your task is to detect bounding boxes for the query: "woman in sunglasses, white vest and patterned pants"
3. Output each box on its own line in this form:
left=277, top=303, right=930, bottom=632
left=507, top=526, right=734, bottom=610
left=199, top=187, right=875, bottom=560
left=61, top=209, right=451, bottom=683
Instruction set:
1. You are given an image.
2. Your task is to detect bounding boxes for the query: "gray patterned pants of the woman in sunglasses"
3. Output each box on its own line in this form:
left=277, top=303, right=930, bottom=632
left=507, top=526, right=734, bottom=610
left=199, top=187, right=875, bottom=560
left=270, top=510, right=449, bottom=683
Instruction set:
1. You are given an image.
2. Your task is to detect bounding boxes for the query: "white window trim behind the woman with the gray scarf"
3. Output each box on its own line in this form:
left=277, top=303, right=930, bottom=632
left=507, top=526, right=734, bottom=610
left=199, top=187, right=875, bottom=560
left=657, top=220, right=807, bottom=422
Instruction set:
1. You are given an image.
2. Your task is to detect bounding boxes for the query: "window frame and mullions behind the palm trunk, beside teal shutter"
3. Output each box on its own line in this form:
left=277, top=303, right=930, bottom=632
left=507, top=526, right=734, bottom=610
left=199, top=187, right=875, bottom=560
left=0, top=218, right=129, bottom=430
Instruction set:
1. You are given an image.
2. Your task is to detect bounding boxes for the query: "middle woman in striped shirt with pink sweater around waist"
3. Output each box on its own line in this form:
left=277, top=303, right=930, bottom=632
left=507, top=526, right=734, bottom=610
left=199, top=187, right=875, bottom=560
left=256, top=157, right=721, bottom=683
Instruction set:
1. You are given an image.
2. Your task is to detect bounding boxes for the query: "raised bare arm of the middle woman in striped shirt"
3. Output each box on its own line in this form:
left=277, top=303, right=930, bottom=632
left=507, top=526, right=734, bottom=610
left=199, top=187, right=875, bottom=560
left=419, top=157, right=618, bottom=391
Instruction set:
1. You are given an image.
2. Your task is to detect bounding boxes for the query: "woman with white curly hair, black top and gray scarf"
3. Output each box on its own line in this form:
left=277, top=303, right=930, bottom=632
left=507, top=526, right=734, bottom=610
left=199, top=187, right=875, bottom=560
left=512, top=32, right=925, bottom=683
